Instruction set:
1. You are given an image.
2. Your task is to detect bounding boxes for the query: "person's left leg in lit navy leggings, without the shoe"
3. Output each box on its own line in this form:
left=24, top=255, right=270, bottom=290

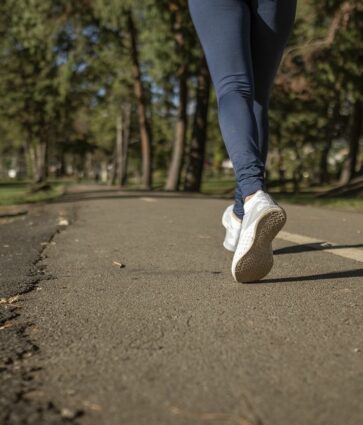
left=188, top=0, right=264, bottom=218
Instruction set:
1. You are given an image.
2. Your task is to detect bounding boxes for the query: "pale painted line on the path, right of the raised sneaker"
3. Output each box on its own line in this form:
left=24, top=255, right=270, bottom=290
left=276, top=231, right=363, bottom=263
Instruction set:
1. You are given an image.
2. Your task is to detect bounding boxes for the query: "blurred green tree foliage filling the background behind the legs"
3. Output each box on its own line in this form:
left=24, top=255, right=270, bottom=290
left=0, top=0, right=363, bottom=189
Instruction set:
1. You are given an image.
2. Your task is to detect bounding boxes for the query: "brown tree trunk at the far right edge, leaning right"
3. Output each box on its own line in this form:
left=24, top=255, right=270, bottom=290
left=340, top=100, right=363, bottom=185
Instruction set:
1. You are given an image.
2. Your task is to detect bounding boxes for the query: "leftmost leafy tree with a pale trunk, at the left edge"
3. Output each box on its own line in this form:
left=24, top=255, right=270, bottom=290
left=0, top=0, right=60, bottom=183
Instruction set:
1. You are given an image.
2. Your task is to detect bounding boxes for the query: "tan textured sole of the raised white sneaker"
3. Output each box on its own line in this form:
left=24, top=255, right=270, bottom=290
left=234, top=207, right=286, bottom=283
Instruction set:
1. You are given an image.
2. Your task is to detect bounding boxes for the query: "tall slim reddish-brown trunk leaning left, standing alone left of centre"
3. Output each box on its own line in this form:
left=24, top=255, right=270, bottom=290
left=127, top=9, right=152, bottom=189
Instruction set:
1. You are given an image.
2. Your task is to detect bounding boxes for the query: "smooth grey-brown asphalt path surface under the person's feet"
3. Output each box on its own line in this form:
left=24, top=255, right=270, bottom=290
left=0, top=191, right=363, bottom=425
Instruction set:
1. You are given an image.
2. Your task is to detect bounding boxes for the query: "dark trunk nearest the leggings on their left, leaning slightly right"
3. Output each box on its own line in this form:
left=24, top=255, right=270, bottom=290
left=184, top=55, right=211, bottom=192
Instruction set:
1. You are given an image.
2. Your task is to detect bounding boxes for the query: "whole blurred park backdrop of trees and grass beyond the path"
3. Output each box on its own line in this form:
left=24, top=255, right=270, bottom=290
left=0, top=0, right=363, bottom=205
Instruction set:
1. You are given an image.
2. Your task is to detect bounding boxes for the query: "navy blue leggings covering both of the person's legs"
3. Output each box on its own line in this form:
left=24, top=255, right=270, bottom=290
left=188, top=0, right=296, bottom=218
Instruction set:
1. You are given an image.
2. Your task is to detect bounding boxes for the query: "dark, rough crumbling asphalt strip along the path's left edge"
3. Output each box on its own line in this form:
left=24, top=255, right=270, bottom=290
left=0, top=207, right=79, bottom=425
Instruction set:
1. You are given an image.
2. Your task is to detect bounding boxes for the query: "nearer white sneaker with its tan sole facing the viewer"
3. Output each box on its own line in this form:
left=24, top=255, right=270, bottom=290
left=232, top=190, right=286, bottom=282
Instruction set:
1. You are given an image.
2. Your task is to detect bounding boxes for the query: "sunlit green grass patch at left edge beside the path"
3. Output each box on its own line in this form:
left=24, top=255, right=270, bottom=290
left=0, top=182, right=64, bottom=206
